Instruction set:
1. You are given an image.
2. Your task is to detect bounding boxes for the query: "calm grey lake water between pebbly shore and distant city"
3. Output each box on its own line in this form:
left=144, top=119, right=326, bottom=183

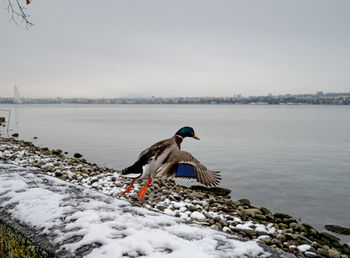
left=0, top=105, right=350, bottom=242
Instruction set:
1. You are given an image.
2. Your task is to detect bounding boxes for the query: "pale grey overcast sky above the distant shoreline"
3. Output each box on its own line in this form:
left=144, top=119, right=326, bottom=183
left=0, top=0, right=350, bottom=97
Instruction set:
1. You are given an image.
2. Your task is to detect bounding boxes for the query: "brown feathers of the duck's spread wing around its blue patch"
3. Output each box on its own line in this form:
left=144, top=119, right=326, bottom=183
left=157, top=150, right=221, bottom=186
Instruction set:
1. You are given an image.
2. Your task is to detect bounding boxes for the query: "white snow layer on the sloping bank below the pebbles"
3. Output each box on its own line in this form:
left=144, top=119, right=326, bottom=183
left=0, top=163, right=276, bottom=257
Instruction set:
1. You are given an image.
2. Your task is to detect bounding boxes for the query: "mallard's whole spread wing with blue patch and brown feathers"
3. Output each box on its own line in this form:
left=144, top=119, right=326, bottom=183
left=157, top=150, right=221, bottom=186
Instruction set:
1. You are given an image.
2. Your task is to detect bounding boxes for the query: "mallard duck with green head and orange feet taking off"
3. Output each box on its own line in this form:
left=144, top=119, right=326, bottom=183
left=121, top=126, right=221, bottom=199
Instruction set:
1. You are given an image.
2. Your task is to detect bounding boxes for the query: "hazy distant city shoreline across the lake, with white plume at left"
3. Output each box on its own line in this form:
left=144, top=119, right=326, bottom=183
left=0, top=86, right=350, bottom=105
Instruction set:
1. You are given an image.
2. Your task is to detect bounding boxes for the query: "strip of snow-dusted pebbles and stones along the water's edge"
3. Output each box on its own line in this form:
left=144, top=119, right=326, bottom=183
left=0, top=138, right=350, bottom=257
